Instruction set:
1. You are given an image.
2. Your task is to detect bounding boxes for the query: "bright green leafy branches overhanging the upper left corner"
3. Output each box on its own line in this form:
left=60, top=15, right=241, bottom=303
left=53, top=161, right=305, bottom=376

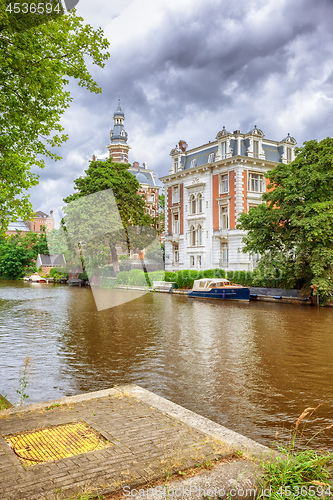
left=0, top=0, right=109, bottom=234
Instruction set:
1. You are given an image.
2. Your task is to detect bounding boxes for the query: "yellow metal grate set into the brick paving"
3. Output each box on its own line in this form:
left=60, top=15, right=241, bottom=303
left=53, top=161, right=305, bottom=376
left=4, top=422, right=112, bottom=467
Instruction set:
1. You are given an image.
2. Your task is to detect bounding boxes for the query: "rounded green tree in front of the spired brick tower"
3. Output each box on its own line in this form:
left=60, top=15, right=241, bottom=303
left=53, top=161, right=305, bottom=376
left=64, top=158, right=155, bottom=271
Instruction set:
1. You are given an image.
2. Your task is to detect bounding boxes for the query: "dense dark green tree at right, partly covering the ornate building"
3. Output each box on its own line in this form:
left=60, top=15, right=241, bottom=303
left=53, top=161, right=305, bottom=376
left=237, top=137, right=333, bottom=302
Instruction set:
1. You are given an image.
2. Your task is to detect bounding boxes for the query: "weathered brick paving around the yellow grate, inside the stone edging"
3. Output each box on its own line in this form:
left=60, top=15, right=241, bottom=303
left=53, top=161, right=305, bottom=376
left=0, top=388, right=231, bottom=500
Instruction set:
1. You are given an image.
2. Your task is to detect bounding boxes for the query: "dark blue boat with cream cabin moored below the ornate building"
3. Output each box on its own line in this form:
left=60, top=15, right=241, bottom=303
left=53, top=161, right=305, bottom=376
left=187, top=278, right=250, bottom=301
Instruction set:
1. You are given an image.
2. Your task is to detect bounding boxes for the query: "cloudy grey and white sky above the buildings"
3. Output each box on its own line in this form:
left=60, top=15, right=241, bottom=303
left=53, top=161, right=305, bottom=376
left=31, top=0, right=333, bottom=227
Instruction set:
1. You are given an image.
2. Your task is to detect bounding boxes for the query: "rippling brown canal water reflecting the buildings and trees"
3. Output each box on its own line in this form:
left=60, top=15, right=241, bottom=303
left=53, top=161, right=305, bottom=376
left=0, top=281, right=333, bottom=451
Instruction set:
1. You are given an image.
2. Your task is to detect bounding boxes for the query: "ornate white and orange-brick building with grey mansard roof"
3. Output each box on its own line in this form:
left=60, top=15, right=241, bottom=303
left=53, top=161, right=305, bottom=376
left=160, top=126, right=296, bottom=271
